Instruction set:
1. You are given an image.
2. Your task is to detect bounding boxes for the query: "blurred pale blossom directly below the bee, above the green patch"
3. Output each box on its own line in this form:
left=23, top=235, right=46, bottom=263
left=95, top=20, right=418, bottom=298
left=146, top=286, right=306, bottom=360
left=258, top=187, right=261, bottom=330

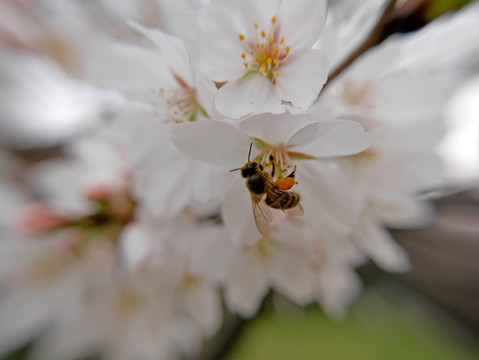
left=188, top=214, right=360, bottom=317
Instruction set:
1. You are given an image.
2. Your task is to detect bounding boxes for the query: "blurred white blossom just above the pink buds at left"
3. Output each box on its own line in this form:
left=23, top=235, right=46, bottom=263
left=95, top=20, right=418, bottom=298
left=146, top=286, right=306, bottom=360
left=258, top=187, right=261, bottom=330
left=26, top=133, right=130, bottom=215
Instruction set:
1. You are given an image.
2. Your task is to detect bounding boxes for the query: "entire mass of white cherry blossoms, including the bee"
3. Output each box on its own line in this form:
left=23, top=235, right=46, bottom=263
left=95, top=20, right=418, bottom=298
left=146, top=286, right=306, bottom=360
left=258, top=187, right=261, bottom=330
left=0, top=0, right=479, bottom=360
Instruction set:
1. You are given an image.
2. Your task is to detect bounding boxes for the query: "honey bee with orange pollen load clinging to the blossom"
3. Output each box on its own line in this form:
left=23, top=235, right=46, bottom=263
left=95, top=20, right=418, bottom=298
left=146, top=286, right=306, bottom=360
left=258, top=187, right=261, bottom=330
left=231, top=143, right=304, bottom=236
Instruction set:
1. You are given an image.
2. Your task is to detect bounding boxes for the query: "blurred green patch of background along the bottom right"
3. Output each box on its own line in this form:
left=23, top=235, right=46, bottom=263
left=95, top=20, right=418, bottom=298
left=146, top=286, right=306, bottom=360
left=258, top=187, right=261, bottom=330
left=226, top=288, right=479, bottom=360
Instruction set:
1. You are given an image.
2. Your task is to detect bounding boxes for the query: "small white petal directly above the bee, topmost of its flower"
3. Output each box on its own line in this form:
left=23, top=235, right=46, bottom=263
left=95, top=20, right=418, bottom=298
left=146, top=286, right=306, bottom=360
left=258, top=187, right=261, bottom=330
left=239, top=112, right=316, bottom=145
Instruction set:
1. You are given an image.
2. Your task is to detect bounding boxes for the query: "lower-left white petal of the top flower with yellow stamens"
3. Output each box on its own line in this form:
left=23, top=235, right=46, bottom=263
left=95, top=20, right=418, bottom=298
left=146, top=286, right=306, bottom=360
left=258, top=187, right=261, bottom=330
left=215, top=73, right=281, bottom=119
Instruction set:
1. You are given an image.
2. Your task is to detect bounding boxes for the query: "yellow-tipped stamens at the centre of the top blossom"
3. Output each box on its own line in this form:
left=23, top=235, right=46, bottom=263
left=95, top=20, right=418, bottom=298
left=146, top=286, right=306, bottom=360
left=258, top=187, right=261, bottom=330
left=238, top=16, right=290, bottom=82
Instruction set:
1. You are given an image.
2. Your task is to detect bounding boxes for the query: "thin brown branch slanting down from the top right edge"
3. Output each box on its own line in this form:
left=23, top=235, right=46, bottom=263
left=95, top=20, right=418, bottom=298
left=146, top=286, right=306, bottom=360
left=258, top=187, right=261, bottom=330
left=323, top=0, right=396, bottom=90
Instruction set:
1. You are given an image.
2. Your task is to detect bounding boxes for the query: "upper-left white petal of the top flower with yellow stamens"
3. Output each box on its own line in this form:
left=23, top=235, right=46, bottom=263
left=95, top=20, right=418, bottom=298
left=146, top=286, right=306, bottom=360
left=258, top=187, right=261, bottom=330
left=177, top=10, right=245, bottom=81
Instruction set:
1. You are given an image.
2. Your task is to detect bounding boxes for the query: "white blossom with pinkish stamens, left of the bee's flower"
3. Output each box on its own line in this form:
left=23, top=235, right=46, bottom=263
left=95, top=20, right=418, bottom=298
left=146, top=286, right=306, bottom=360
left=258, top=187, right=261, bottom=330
left=70, top=22, right=226, bottom=217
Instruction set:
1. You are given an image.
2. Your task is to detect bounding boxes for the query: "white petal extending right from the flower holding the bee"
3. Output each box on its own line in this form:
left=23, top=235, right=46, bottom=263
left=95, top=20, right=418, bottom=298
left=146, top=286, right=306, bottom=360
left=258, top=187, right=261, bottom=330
left=296, top=120, right=376, bottom=157
